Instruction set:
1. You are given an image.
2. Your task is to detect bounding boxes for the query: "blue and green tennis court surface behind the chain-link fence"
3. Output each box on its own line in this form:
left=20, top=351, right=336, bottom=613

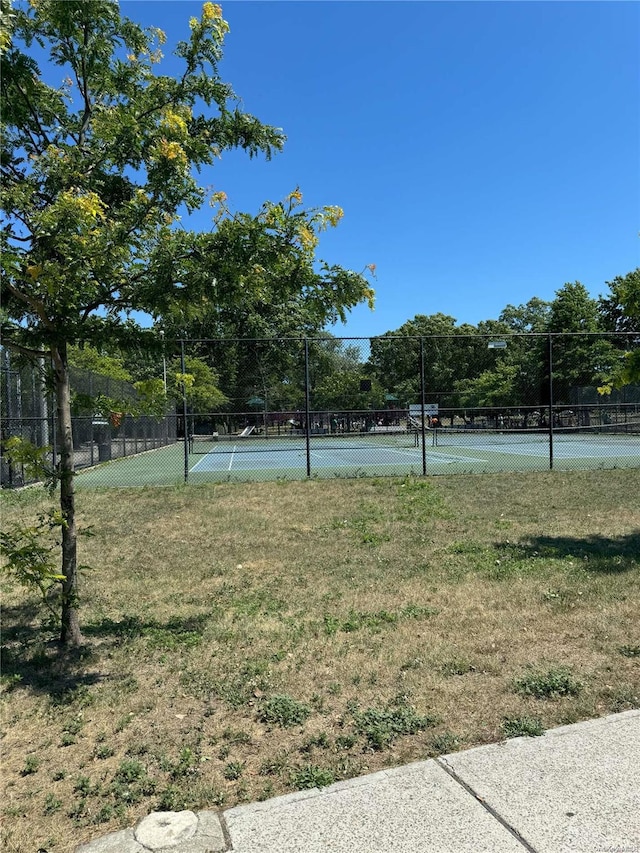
left=77, top=428, right=640, bottom=488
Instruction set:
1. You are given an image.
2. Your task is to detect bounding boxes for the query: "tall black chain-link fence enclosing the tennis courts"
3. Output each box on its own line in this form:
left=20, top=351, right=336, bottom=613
left=2, top=334, right=640, bottom=486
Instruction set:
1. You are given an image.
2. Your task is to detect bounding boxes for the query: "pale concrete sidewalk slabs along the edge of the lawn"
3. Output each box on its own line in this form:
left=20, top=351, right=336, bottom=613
left=77, top=710, right=640, bottom=853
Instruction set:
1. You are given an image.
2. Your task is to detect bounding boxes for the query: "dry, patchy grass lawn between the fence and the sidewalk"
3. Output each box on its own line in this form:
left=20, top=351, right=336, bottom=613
left=1, top=470, right=640, bottom=853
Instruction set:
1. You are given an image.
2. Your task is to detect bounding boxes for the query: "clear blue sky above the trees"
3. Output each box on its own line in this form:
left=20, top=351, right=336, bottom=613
left=121, top=0, right=640, bottom=336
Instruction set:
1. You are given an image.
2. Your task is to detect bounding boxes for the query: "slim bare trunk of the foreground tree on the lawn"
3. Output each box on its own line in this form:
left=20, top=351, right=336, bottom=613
left=52, top=344, right=83, bottom=646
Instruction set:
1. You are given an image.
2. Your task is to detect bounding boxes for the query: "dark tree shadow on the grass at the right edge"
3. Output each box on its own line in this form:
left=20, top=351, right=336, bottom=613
left=519, top=532, right=640, bottom=575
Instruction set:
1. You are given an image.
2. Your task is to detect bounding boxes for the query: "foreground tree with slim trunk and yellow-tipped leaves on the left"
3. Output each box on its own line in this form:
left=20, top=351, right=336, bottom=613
left=0, top=0, right=350, bottom=644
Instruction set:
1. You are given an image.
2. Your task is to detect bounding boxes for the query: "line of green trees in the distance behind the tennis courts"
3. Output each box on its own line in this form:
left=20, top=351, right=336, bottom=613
left=84, top=269, right=640, bottom=412
